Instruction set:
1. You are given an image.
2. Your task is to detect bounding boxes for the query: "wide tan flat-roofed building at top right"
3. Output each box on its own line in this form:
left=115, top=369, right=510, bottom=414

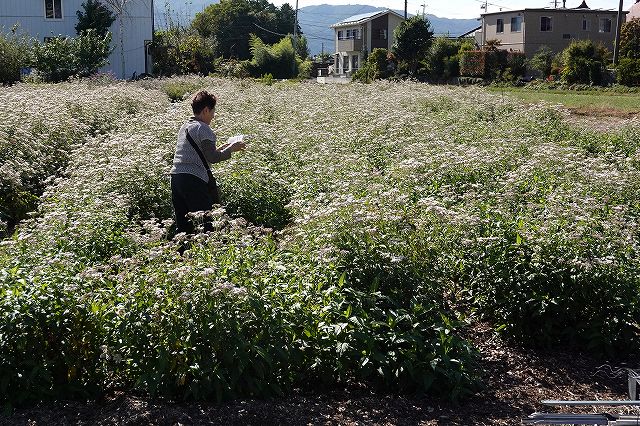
left=476, top=1, right=629, bottom=58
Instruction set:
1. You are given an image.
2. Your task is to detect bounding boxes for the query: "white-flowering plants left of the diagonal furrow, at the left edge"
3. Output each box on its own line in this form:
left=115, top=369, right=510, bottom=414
left=0, top=83, right=166, bottom=232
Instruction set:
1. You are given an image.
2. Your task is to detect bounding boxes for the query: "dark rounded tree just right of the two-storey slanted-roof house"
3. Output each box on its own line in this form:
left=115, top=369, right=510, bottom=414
left=392, top=16, right=433, bottom=75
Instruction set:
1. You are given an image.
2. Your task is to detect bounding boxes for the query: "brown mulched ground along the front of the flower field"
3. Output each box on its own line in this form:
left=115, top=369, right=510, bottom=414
left=0, top=325, right=640, bottom=426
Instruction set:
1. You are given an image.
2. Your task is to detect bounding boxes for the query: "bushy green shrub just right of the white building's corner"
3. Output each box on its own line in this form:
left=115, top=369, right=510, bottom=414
left=151, top=27, right=218, bottom=76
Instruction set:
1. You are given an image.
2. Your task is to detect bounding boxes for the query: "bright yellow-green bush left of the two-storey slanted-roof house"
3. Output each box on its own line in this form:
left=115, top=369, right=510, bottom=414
left=249, top=34, right=298, bottom=79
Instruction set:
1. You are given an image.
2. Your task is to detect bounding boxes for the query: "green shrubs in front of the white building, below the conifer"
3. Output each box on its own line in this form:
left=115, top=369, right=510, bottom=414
left=33, top=29, right=111, bottom=82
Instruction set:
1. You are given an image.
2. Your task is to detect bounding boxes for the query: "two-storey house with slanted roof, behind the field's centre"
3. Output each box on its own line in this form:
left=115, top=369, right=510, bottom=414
left=331, top=9, right=404, bottom=76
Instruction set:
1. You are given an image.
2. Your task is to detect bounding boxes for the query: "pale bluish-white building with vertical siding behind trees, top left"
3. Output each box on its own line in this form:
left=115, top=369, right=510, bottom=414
left=0, top=0, right=153, bottom=78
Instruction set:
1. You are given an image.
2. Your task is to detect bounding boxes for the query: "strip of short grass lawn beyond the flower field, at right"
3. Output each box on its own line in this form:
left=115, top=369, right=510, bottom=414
left=489, top=87, right=640, bottom=116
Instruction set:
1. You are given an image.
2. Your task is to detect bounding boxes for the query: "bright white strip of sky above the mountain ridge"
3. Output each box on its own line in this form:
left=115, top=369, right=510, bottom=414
left=271, top=0, right=636, bottom=19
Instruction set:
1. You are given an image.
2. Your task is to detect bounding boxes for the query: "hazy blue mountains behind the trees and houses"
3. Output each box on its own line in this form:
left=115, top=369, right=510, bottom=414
left=155, top=0, right=479, bottom=55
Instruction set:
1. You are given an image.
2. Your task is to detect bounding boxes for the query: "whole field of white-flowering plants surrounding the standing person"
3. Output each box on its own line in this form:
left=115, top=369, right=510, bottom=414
left=0, top=78, right=640, bottom=405
